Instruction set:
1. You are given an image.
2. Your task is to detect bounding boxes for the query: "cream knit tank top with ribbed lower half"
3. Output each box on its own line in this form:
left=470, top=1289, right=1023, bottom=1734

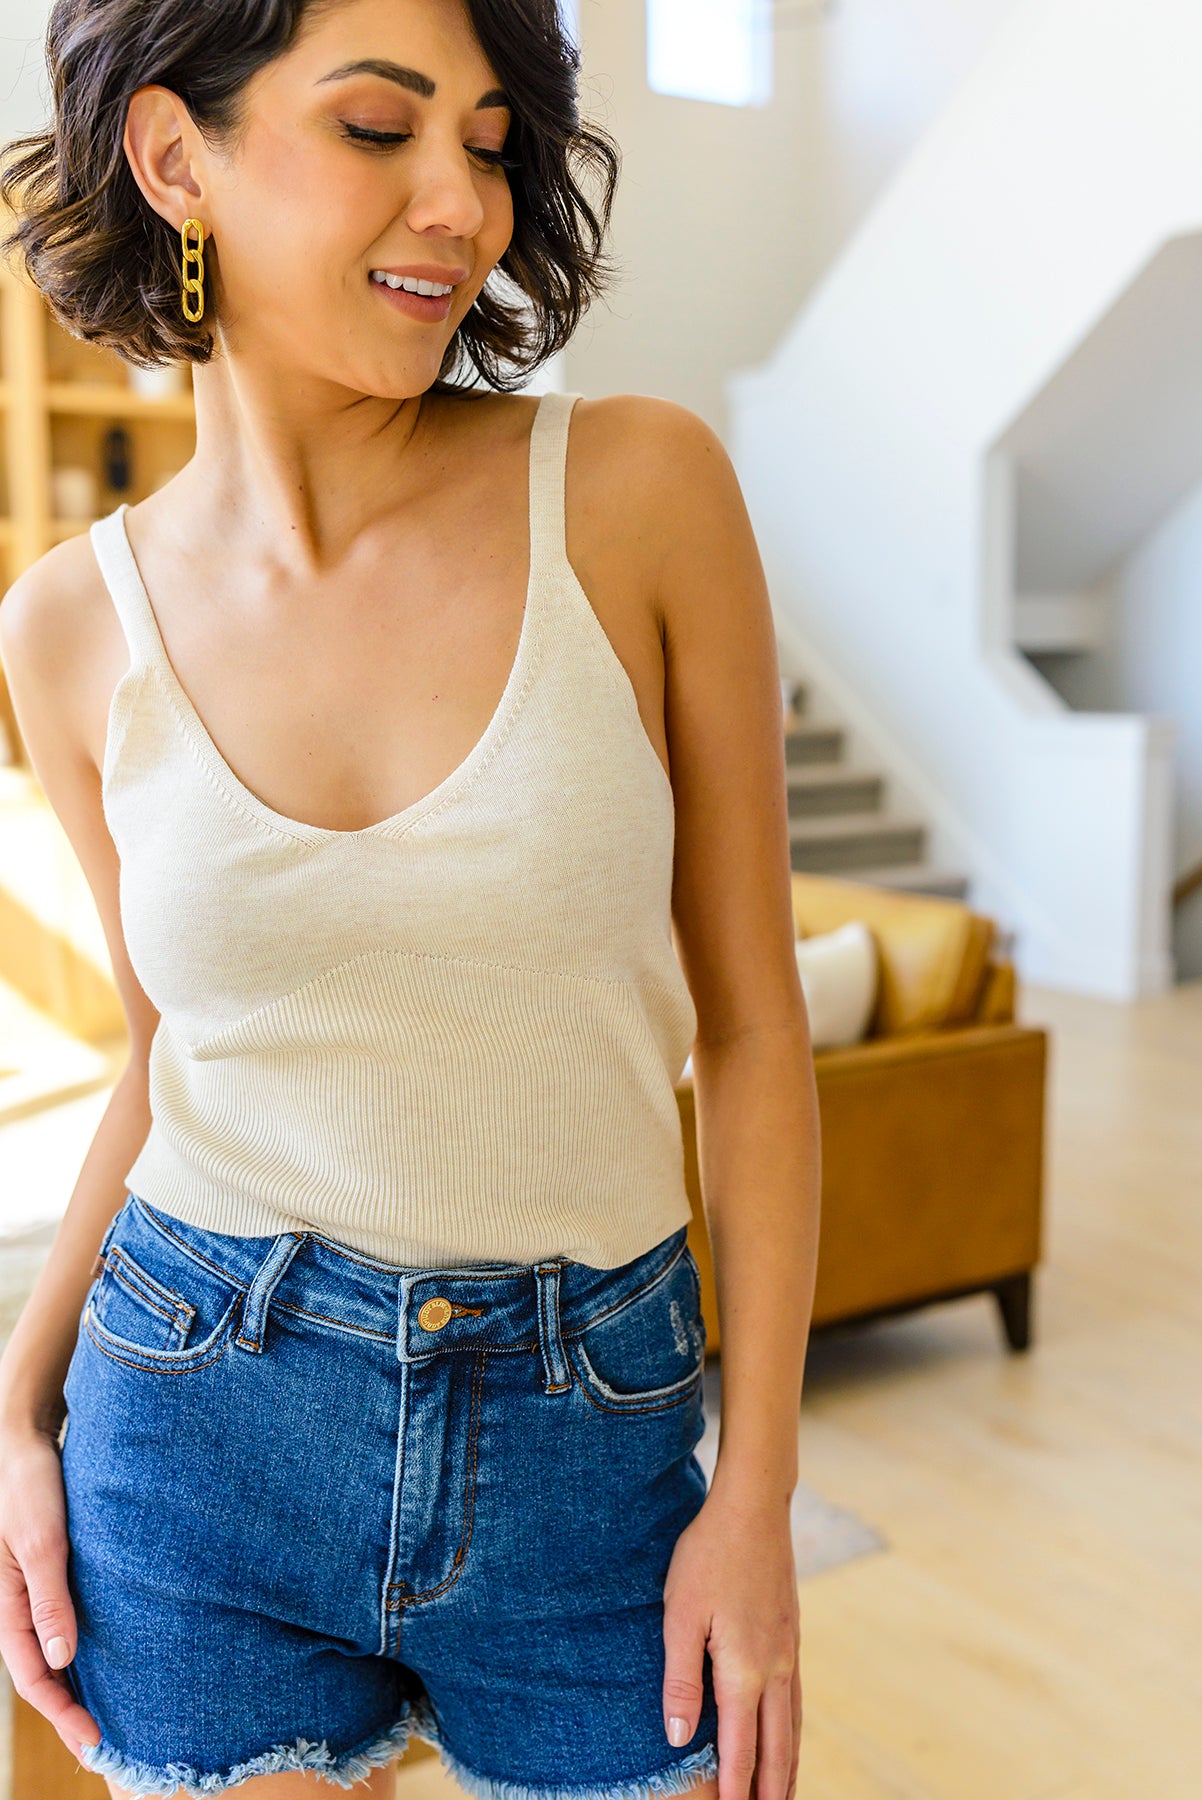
left=90, top=392, right=696, bottom=1267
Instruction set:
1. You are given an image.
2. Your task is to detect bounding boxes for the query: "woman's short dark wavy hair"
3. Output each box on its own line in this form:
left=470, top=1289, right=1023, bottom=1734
left=0, top=0, right=621, bottom=392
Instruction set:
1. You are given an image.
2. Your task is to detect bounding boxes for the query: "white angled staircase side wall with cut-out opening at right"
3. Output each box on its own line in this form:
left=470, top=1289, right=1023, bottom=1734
left=732, top=0, right=1202, bottom=999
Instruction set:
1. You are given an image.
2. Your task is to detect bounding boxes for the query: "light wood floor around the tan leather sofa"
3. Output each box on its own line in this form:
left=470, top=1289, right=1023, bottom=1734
left=4, top=983, right=1202, bottom=1800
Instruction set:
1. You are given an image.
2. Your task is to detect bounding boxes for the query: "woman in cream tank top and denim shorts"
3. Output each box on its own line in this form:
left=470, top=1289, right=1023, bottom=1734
left=0, top=0, right=819, bottom=1800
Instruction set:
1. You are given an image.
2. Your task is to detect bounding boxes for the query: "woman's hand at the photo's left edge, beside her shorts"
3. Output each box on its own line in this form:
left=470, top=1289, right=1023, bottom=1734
left=0, top=1426, right=101, bottom=1757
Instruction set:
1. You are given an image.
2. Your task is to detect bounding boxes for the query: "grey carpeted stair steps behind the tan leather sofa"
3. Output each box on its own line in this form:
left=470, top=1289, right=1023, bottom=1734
left=781, top=680, right=968, bottom=900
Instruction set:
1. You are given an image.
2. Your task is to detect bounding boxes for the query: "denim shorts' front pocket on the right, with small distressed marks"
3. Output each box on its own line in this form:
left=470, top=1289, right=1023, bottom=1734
left=565, top=1244, right=705, bottom=1411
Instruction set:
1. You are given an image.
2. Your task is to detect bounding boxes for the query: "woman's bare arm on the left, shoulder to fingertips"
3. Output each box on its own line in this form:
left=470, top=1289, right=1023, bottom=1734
left=0, top=544, right=158, bottom=1755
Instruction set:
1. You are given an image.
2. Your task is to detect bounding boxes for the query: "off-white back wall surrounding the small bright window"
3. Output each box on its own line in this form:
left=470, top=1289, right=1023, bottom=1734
left=565, top=0, right=1015, bottom=437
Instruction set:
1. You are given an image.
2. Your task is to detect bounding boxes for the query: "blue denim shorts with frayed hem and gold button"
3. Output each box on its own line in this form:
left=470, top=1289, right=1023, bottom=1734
left=61, top=1193, right=718, bottom=1800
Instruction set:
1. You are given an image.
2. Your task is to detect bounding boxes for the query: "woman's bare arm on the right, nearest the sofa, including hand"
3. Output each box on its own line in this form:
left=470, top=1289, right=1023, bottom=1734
left=597, top=396, right=821, bottom=1800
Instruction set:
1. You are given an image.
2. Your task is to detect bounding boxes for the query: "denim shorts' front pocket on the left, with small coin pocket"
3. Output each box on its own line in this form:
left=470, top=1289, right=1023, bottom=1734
left=83, top=1206, right=243, bottom=1373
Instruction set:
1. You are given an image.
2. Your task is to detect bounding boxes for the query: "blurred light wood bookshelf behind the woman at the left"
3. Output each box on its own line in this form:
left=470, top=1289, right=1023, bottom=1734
left=0, top=207, right=196, bottom=765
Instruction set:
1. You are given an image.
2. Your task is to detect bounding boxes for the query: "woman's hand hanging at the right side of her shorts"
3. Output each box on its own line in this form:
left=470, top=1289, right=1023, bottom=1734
left=664, top=1487, right=801, bottom=1800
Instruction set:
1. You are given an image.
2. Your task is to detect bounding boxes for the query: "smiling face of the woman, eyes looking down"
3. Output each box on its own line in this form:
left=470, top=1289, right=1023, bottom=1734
left=180, top=0, right=513, bottom=398
